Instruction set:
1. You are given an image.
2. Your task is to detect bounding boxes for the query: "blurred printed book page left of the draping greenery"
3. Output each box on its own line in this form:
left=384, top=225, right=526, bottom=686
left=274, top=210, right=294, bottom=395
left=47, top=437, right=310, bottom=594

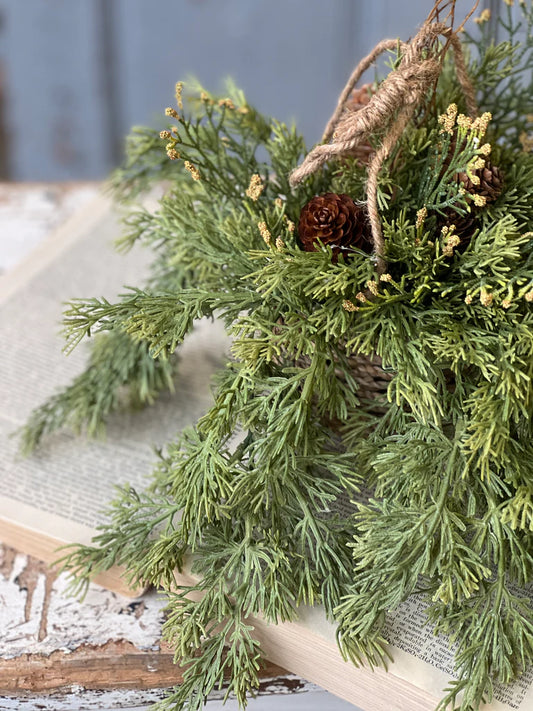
left=0, top=198, right=228, bottom=540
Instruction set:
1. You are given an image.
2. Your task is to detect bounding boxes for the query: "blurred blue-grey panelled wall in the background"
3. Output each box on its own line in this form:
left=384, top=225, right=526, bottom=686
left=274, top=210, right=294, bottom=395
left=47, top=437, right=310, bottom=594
left=0, top=0, right=502, bottom=181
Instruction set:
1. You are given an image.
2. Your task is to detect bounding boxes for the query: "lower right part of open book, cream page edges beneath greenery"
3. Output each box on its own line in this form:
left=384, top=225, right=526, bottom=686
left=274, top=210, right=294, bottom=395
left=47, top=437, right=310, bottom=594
left=175, top=572, right=533, bottom=711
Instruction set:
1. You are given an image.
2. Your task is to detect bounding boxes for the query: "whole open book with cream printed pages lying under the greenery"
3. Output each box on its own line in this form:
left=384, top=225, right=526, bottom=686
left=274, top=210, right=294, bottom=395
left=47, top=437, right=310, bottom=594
left=4, top=198, right=533, bottom=711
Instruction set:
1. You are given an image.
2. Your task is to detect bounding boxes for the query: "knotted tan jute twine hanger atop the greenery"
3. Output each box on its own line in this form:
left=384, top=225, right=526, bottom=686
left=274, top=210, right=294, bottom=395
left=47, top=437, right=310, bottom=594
left=290, top=0, right=479, bottom=274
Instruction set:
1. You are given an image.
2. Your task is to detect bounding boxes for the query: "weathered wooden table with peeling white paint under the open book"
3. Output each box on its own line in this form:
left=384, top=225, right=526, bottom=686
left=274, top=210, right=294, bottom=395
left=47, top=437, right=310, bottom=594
left=0, top=183, right=354, bottom=711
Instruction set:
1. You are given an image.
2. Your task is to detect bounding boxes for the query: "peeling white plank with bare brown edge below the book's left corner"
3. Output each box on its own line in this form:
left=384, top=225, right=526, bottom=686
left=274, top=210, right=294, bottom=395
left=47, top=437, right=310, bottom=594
left=0, top=546, right=290, bottom=695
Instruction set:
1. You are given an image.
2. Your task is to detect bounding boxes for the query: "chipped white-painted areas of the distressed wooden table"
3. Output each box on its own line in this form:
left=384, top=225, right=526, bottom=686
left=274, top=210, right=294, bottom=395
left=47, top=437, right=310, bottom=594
left=0, top=184, right=362, bottom=711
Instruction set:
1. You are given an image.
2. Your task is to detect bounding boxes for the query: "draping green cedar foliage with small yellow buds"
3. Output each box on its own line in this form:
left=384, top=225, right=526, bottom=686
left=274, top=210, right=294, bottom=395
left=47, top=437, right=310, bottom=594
left=23, top=3, right=533, bottom=711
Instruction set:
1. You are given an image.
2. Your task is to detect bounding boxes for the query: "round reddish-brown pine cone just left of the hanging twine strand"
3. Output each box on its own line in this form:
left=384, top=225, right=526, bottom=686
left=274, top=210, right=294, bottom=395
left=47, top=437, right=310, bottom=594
left=298, top=193, right=372, bottom=262
